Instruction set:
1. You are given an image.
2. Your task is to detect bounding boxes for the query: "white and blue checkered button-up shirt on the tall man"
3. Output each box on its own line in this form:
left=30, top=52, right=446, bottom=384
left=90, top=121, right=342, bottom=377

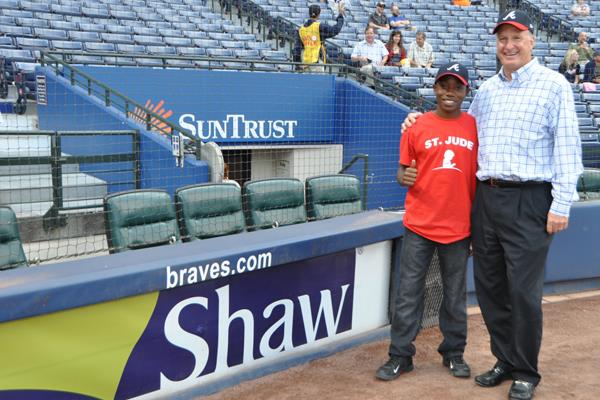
left=469, top=59, right=583, bottom=217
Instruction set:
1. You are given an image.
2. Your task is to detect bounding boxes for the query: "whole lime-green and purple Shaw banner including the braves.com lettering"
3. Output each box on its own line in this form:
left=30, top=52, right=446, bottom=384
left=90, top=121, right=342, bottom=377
left=0, top=249, right=387, bottom=400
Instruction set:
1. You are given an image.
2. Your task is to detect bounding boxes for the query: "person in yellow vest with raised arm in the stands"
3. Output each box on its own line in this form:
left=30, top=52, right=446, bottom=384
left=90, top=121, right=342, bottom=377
left=294, top=2, right=346, bottom=69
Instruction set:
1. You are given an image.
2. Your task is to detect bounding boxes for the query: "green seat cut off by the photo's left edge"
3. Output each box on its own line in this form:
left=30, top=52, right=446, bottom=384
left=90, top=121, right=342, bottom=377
left=0, top=206, right=28, bottom=270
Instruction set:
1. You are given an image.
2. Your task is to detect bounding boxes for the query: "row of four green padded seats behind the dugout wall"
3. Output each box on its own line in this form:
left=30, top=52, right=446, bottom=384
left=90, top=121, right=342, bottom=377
left=104, top=174, right=363, bottom=253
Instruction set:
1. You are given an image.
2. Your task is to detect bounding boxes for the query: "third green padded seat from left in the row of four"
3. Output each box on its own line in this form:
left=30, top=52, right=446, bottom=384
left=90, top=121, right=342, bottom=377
left=244, top=178, right=306, bottom=230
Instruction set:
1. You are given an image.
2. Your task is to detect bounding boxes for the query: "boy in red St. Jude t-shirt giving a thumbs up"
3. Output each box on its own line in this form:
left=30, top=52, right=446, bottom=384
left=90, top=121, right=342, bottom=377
left=376, top=63, right=477, bottom=380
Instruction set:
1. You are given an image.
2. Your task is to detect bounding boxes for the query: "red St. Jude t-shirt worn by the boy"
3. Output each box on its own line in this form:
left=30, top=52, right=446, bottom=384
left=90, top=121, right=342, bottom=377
left=400, top=112, right=478, bottom=243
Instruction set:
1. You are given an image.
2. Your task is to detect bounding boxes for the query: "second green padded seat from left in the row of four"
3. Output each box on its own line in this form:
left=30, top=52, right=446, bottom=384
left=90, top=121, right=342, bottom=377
left=175, top=183, right=245, bottom=240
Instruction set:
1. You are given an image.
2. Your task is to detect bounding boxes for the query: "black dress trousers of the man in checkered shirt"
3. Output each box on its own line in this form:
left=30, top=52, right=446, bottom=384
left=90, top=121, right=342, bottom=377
left=471, top=183, right=552, bottom=384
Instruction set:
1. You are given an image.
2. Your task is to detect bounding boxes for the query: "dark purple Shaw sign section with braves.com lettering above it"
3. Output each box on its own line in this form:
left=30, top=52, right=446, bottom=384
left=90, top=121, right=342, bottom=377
left=115, top=249, right=356, bottom=399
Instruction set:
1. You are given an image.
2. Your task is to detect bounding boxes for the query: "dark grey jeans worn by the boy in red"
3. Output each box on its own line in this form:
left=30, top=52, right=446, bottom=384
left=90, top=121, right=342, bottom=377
left=389, top=229, right=470, bottom=357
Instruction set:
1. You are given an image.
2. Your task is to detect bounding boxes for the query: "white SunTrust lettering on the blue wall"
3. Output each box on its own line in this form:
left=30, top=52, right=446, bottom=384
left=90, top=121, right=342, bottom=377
left=179, top=114, right=298, bottom=141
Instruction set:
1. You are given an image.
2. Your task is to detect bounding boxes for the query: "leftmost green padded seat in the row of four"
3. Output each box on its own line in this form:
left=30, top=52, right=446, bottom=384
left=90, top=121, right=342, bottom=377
left=104, top=189, right=181, bottom=253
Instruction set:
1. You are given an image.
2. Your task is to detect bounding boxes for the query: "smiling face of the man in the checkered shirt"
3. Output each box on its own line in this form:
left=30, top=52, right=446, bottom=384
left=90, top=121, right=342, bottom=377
left=496, top=24, right=535, bottom=74
